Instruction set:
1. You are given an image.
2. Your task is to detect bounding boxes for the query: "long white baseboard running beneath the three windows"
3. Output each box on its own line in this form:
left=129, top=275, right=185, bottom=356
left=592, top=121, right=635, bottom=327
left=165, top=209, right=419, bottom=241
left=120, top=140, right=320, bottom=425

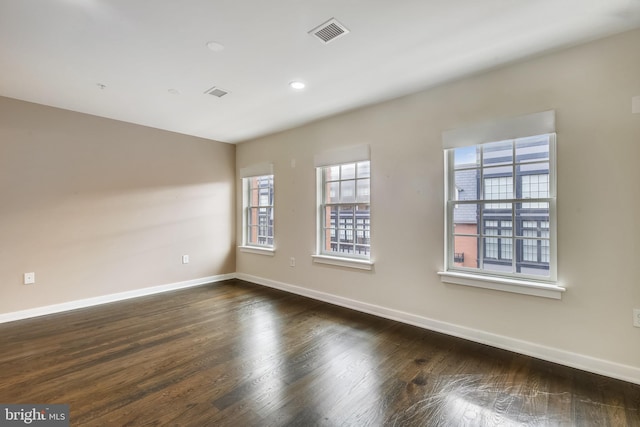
left=235, top=273, right=640, bottom=384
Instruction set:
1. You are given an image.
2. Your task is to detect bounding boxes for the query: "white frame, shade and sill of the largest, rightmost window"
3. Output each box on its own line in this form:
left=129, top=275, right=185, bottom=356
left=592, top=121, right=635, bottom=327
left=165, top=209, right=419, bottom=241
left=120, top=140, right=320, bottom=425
left=438, top=111, right=566, bottom=299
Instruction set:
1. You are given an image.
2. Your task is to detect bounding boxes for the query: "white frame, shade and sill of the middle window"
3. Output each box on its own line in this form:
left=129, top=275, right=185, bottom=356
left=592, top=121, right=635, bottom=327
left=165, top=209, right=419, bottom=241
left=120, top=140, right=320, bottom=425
left=312, top=145, right=374, bottom=270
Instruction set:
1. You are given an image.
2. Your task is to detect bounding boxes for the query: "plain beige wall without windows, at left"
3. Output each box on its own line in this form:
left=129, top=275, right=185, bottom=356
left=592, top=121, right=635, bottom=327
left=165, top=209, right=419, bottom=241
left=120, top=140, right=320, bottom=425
left=0, top=98, right=235, bottom=314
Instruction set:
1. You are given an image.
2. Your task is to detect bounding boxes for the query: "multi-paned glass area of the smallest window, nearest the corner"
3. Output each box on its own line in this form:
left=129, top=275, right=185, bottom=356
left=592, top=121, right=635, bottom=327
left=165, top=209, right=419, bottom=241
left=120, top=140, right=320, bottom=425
left=243, top=175, right=274, bottom=248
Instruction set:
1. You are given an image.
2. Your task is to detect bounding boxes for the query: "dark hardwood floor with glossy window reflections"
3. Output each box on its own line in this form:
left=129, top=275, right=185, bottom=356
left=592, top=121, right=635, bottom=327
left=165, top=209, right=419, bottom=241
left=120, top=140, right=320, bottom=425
left=0, top=280, right=640, bottom=426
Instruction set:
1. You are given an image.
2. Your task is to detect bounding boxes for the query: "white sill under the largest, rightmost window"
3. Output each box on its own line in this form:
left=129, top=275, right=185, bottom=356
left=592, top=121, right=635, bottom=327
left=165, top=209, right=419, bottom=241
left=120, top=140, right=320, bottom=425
left=438, top=271, right=566, bottom=299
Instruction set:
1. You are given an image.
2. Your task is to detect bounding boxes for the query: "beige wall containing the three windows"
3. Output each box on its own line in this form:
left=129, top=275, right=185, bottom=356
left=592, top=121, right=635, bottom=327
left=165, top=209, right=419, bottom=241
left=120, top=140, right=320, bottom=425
left=236, top=31, right=640, bottom=368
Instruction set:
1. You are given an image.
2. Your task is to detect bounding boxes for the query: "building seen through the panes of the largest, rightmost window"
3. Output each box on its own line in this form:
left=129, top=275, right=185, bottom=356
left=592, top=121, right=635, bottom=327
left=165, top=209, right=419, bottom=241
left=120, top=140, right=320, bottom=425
left=449, top=135, right=552, bottom=278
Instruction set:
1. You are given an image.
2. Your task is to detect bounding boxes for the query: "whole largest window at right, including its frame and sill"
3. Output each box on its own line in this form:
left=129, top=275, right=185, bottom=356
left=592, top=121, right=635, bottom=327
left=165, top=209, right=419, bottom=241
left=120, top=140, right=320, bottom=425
left=440, top=108, right=564, bottom=298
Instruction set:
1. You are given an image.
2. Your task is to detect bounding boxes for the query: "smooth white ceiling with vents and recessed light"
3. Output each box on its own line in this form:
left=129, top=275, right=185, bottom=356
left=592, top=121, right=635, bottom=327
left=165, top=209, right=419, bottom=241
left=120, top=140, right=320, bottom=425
left=0, top=0, right=640, bottom=143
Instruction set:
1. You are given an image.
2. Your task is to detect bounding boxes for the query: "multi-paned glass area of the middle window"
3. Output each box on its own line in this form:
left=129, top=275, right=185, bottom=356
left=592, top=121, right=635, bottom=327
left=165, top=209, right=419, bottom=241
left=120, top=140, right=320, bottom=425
left=318, top=161, right=371, bottom=259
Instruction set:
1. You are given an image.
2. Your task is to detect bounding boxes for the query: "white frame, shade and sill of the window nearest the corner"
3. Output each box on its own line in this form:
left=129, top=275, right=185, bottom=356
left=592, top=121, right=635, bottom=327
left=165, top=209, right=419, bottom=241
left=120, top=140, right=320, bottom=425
left=239, top=164, right=276, bottom=256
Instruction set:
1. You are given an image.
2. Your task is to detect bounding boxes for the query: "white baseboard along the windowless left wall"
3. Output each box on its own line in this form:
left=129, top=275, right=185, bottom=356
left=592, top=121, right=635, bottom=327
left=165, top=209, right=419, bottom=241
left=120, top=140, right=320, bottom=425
left=0, top=273, right=236, bottom=323
